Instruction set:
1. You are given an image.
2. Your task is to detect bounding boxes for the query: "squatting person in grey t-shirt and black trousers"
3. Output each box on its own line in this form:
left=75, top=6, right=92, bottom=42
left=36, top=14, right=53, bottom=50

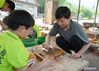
left=44, top=6, right=90, bottom=58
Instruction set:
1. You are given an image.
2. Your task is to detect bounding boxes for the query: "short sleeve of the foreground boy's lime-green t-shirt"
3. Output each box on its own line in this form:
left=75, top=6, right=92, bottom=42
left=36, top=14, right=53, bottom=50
left=6, top=42, right=29, bottom=68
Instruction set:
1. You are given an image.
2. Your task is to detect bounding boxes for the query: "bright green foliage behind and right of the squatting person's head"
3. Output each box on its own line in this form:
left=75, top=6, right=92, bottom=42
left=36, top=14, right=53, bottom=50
left=57, top=0, right=94, bottom=19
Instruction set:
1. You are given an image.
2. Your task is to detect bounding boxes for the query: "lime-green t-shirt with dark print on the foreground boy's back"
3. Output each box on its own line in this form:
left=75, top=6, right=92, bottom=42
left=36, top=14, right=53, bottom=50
left=0, top=31, right=29, bottom=71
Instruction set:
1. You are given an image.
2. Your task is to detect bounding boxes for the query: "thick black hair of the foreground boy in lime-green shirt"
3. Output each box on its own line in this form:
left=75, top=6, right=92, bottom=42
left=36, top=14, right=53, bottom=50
left=6, top=10, right=35, bottom=30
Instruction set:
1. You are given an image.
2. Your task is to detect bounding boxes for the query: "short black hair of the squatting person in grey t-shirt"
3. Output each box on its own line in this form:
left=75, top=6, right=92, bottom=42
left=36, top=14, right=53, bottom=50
left=55, top=6, right=71, bottom=19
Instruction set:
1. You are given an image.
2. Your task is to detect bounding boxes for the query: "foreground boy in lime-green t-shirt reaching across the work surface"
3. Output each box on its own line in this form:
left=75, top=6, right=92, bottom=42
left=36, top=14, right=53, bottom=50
left=0, top=10, right=51, bottom=71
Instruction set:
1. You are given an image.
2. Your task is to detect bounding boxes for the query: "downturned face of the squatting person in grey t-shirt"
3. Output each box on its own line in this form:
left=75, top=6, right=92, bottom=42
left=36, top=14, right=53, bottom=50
left=57, top=17, right=70, bottom=28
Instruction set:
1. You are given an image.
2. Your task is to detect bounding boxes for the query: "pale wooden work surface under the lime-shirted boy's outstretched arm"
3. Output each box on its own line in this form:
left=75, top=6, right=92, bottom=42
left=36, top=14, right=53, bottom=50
left=29, top=46, right=89, bottom=71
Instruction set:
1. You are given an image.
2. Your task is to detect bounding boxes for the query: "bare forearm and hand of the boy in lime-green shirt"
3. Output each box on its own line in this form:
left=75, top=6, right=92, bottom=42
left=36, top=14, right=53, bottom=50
left=16, top=56, right=54, bottom=71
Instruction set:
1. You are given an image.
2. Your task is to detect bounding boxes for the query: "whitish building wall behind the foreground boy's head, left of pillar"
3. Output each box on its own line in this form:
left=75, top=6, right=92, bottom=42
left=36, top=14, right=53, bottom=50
left=15, top=1, right=38, bottom=17
